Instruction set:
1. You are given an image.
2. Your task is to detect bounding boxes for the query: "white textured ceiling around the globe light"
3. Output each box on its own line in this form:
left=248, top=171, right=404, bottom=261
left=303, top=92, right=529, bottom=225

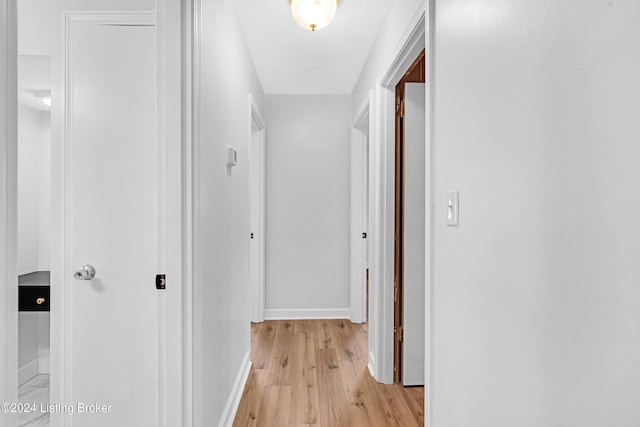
left=233, top=0, right=390, bottom=94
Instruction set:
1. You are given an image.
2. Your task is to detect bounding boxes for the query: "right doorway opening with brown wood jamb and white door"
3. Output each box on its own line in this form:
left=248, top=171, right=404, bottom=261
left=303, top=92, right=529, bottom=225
left=393, top=50, right=426, bottom=385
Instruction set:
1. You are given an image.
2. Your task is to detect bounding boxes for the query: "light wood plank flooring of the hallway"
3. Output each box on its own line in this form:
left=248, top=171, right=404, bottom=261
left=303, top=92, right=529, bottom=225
left=233, top=320, right=424, bottom=427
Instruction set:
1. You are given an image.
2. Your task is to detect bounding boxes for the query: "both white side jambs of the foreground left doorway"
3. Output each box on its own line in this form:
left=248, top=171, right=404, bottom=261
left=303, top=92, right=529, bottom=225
left=0, top=0, right=193, bottom=427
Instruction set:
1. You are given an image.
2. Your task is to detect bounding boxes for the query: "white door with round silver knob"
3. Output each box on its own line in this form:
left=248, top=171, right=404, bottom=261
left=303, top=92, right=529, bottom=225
left=62, top=15, right=158, bottom=427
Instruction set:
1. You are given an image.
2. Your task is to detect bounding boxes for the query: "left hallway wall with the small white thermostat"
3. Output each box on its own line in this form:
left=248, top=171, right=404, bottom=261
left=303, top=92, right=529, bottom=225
left=194, top=1, right=263, bottom=426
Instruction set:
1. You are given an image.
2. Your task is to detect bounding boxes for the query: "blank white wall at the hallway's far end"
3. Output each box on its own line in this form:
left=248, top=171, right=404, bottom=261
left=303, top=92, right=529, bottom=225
left=265, top=95, right=350, bottom=317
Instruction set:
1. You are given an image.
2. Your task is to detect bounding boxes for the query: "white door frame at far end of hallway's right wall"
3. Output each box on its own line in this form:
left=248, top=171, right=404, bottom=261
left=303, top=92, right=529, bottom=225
left=350, top=91, right=373, bottom=323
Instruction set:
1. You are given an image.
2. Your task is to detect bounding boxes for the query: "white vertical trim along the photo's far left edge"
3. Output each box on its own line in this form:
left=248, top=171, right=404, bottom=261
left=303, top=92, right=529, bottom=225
left=0, top=0, right=18, bottom=418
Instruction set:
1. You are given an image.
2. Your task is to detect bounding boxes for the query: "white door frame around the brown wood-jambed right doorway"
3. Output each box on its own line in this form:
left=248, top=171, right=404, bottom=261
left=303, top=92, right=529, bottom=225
left=369, top=0, right=435, bottom=427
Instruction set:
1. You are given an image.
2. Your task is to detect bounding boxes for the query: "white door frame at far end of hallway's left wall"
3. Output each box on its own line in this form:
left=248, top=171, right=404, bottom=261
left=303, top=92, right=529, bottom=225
left=249, top=94, right=266, bottom=322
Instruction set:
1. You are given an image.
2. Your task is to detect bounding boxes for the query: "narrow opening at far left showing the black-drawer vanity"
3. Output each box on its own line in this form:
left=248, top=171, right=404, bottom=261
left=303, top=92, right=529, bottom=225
left=16, top=3, right=55, bottom=425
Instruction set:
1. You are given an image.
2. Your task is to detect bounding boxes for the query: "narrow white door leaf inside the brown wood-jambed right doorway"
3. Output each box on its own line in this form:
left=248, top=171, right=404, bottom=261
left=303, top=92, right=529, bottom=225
left=402, top=83, right=425, bottom=386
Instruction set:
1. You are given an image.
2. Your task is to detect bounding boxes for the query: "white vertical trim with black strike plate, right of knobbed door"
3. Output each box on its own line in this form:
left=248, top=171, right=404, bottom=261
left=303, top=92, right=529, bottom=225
left=156, top=0, right=192, bottom=427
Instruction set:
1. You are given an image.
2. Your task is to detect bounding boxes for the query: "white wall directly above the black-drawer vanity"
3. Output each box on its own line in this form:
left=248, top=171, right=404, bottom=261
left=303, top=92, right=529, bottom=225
left=18, top=105, right=51, bottom=274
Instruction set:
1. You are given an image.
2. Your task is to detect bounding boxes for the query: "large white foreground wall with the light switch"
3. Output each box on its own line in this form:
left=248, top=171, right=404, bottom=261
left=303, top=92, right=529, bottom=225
left=433, top=0, right=640, bottom=427
